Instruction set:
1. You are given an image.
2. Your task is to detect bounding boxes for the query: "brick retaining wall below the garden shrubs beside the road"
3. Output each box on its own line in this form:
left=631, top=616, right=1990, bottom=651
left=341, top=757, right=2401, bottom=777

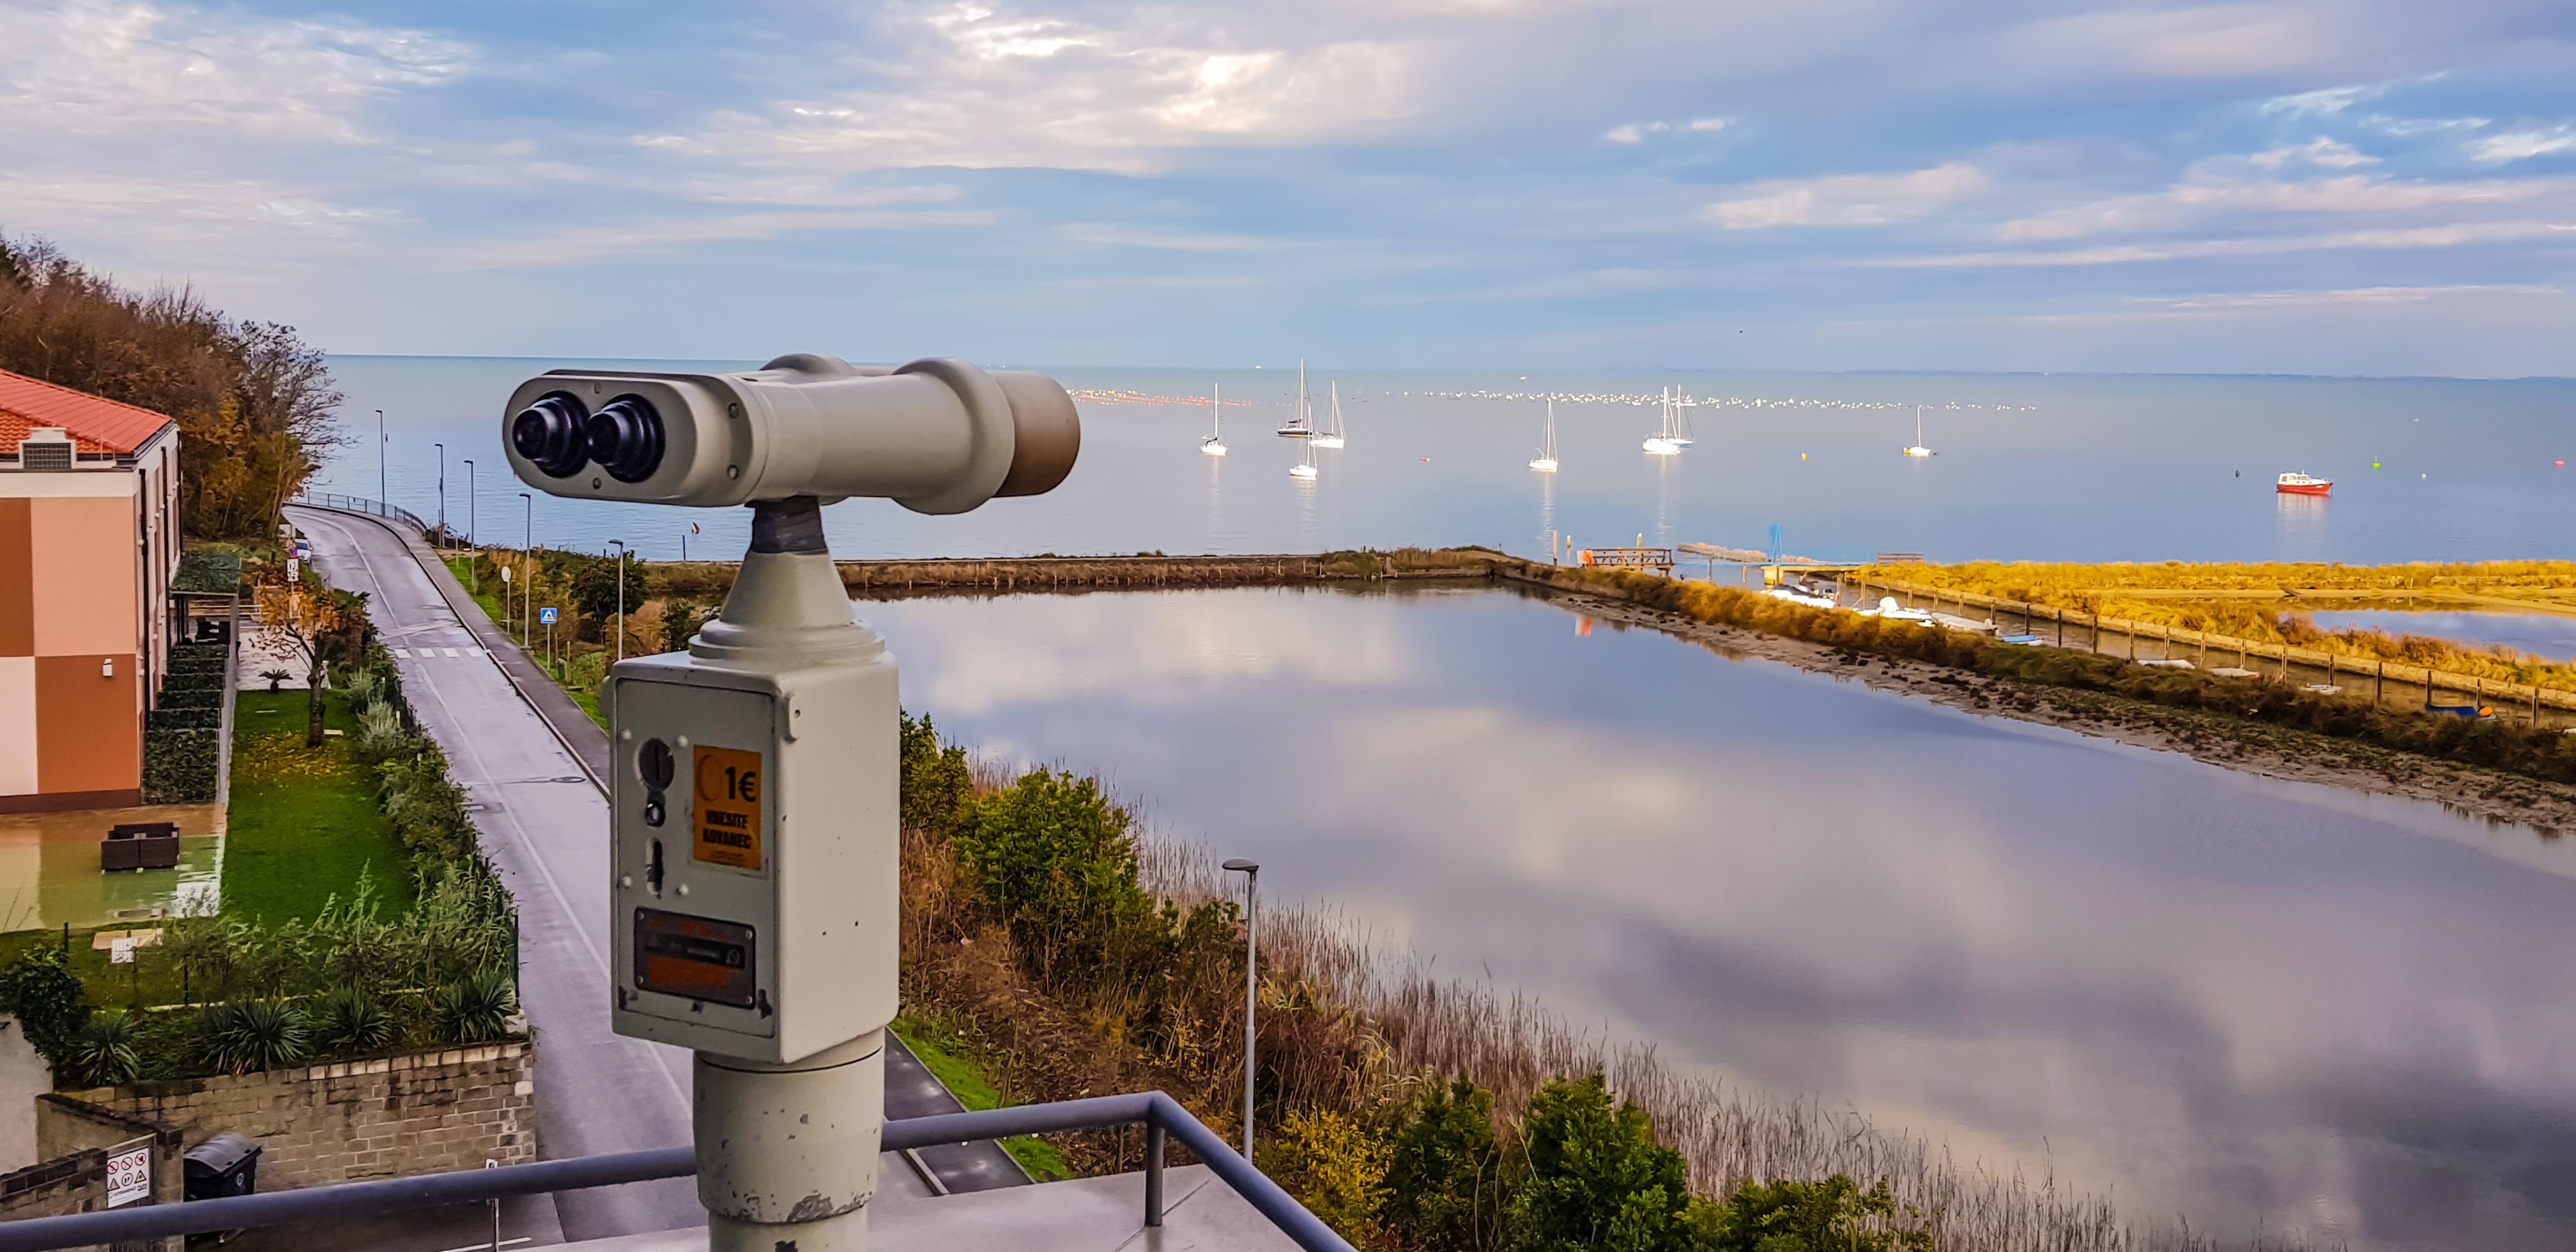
left=36, top=1043, right=536, bottom=1190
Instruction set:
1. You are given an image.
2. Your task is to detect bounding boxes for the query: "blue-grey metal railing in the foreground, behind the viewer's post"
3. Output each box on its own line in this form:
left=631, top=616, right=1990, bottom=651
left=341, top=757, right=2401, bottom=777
left=0, top=1092, right=1353, bottom=1252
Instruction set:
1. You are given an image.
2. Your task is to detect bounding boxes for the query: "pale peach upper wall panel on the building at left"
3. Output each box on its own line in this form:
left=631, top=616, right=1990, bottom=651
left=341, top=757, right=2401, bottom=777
left=28, top=494, right=139, bottom=659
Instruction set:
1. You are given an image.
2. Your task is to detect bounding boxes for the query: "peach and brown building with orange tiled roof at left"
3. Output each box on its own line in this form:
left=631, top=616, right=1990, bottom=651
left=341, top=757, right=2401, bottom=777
left=0, top=371, right=180, bottom=814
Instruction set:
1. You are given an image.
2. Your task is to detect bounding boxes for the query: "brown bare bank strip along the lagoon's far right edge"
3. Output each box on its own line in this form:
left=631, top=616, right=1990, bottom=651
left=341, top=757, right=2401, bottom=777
left=1538, top=590, right=2576, bottom=832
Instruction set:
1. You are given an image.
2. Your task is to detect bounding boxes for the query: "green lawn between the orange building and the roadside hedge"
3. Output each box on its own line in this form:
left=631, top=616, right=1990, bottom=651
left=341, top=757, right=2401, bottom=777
left=224, top=691, right=412, bottom=922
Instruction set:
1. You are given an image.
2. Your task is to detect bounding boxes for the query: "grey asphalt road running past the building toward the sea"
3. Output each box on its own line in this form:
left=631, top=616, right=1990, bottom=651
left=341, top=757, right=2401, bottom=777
left=289, top=507, right=1028, bottom=1231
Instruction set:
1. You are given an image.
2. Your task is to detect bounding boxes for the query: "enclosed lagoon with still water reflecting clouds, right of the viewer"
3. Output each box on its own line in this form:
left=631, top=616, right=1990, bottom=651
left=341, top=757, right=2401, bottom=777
left=861, top=590, right=2576, bottom=1249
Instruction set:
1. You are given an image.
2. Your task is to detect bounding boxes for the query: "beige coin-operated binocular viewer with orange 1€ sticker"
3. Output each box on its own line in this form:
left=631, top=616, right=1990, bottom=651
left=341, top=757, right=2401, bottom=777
left=502, top=356, right=1082, bottom=1252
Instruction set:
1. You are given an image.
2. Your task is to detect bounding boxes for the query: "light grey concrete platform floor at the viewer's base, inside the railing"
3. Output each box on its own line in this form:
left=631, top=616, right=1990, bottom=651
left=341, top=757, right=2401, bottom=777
left=567, top=1164, right=1296, bottom=1252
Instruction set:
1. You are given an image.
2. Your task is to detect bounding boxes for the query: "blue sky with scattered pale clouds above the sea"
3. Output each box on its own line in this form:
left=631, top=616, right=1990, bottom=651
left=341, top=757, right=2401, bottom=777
left=0, top=0, right=2576, bottom=376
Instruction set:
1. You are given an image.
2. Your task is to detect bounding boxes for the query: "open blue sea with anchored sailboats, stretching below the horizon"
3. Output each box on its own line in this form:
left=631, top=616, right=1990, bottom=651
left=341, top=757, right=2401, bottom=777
left=319, top=356, right=2576, bottom=561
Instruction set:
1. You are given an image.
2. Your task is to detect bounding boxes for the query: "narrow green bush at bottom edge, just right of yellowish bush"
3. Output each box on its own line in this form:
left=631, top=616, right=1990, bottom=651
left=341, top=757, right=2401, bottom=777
left=1381, top=1080, right=1510, bottom=1252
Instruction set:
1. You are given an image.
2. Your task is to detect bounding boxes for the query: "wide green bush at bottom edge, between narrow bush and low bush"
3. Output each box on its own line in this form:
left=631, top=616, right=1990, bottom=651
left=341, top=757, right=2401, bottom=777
left=1512, top=1074, right=1698, bottom=1252
